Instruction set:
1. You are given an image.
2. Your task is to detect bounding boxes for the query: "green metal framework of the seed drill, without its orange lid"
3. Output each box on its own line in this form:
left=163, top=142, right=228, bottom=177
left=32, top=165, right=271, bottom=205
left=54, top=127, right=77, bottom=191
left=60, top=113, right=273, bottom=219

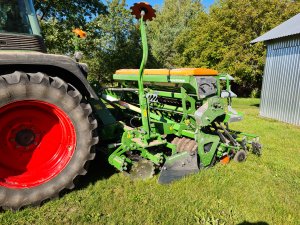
left=98, top=6, right=257, bottom=171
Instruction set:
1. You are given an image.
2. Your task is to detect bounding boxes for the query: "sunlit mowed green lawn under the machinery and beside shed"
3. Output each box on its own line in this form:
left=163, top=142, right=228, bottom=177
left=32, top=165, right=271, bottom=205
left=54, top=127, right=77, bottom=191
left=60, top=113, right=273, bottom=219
left=0, top=99, right=300, bottom=224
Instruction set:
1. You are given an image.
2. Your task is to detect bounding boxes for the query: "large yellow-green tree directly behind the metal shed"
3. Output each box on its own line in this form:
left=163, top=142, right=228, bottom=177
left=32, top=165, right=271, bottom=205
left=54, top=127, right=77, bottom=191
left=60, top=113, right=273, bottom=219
left=176, top=0, right=300, bottom=96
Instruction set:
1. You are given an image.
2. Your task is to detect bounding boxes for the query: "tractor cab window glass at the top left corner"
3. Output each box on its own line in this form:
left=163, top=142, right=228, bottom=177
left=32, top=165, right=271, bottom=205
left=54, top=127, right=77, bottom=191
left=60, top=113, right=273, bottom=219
left=0, top=0, right=40, bottom=35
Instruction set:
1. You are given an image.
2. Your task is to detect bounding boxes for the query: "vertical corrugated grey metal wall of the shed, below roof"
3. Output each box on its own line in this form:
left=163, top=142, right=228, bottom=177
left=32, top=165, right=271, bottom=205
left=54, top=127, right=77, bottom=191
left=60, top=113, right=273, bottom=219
left=260, top=36, right=300, bottom=126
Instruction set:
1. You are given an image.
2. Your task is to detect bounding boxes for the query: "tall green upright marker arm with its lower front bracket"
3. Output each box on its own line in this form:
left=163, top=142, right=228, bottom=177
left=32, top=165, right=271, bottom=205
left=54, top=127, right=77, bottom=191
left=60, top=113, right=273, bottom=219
left=106, top=11, right=172, bottom=171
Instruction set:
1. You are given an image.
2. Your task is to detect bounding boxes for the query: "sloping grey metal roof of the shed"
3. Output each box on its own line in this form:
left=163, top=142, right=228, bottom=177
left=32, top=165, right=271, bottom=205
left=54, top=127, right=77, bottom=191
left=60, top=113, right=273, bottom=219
left=250, top=13, right=300, bottom=44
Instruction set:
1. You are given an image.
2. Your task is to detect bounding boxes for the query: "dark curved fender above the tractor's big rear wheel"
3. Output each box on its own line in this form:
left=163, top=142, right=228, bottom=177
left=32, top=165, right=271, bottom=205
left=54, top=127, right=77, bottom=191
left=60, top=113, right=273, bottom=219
left=0, top=51, right=99, bottom=100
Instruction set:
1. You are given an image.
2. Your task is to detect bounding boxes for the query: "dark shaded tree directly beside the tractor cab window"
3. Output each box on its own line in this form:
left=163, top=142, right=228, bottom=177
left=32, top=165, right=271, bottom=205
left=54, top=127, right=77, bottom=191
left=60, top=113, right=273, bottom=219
left=35, top=0, right=107, bottom=54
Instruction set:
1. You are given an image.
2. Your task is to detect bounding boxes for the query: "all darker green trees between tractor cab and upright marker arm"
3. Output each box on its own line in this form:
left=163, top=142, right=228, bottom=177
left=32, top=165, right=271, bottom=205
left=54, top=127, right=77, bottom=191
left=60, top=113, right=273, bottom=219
left=36, top=0, right=146, bottom=83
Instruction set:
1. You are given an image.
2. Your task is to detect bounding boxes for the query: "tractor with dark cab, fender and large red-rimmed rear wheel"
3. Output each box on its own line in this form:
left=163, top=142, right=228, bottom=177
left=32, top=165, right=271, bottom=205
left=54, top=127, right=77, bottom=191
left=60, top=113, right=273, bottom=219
left=0, top=0, right=98, bottom=209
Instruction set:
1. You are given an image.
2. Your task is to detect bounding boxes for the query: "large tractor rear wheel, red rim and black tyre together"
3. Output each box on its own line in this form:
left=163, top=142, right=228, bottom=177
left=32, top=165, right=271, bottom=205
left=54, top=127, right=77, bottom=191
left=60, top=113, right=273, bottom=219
left=0, top=72, right=98, bottom=210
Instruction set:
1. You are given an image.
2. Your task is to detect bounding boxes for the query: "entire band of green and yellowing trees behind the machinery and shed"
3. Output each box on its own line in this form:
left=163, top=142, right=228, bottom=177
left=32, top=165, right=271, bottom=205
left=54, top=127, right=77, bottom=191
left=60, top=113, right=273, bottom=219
left=36, top=0, right=300, bottom=97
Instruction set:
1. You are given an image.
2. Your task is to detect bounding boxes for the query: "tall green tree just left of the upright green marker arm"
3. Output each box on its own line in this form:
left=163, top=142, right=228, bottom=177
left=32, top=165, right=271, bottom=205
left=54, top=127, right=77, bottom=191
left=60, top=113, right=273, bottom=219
left=85, top=0, right=141, bottom=83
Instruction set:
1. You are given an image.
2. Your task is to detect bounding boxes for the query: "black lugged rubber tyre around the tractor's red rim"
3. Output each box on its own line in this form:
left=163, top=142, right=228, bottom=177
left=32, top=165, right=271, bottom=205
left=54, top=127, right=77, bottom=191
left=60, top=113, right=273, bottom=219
left=0, top=71, right=98, bottom=210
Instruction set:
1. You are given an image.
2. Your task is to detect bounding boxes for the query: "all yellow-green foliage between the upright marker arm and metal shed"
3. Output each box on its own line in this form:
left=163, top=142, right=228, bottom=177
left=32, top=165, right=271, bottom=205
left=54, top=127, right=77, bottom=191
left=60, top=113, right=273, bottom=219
left=151, top=0, right=300, bottom=96
